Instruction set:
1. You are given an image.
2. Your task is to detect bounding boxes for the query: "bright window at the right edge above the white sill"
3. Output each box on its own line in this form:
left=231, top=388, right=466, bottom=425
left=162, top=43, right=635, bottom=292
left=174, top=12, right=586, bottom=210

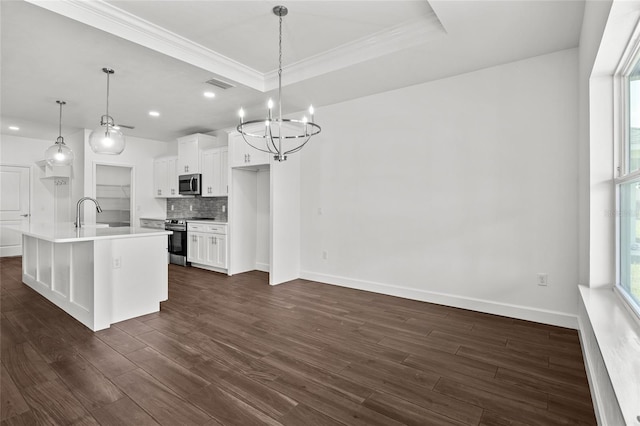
left=616, top=49, right=640, bottom=314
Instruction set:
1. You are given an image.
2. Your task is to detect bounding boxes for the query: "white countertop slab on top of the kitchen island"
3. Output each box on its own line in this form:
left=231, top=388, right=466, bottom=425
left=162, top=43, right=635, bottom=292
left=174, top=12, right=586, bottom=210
left=16, top=223, right=173, bottom=243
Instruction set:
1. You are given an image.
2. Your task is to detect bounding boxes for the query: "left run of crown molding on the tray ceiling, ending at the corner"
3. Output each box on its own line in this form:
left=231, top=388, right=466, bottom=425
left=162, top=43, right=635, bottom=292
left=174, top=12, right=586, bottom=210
left=26, top=0, right=264, bottom=91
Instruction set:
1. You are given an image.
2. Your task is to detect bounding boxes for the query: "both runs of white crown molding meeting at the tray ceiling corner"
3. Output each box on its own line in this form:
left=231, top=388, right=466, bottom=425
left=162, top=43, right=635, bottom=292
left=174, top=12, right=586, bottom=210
left=25, top=0, right=446, bottom=92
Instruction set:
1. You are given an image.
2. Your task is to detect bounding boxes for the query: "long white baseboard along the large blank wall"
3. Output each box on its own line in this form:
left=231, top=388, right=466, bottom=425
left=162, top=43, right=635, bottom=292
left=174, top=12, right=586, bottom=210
left=300, top=271, right=578, bottom=330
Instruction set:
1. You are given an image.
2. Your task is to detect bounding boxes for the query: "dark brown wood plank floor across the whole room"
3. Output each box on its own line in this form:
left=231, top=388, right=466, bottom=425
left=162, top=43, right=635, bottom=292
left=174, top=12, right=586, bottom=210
left=0, top=258, right=596, bottom=426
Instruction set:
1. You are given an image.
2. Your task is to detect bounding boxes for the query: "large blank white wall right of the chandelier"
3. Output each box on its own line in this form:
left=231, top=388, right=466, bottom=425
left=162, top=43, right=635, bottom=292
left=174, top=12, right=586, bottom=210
left=301, top=49, right=578, bottom=327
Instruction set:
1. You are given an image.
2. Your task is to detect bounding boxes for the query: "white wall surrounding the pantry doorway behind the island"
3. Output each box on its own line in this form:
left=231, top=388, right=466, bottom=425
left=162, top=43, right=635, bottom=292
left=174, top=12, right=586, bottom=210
left=83, top=130, right=170, bottom=226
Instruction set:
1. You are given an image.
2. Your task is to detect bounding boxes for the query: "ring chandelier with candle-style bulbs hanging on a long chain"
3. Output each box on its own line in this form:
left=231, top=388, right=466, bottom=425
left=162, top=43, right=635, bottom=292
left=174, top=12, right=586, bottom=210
left=237, top=6, right=321, bottom=161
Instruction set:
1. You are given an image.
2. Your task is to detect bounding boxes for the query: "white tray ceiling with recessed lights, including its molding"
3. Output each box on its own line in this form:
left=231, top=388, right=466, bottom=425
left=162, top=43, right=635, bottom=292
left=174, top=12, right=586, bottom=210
left=0, top=0, right=584, bottom=141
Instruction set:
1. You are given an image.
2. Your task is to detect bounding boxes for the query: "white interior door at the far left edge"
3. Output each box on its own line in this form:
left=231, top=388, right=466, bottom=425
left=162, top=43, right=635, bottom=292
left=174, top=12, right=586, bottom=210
left=0, top=166, right=31, bottom=257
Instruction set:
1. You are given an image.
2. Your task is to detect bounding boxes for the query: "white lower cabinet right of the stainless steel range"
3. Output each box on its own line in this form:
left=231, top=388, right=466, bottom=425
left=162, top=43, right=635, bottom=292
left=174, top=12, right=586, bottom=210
left=187, top=222, right=228, bottom=270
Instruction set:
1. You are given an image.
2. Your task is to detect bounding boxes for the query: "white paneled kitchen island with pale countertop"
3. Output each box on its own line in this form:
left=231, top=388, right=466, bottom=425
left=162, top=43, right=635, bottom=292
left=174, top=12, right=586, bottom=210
left=21, top=223, right=171, bottom=331
